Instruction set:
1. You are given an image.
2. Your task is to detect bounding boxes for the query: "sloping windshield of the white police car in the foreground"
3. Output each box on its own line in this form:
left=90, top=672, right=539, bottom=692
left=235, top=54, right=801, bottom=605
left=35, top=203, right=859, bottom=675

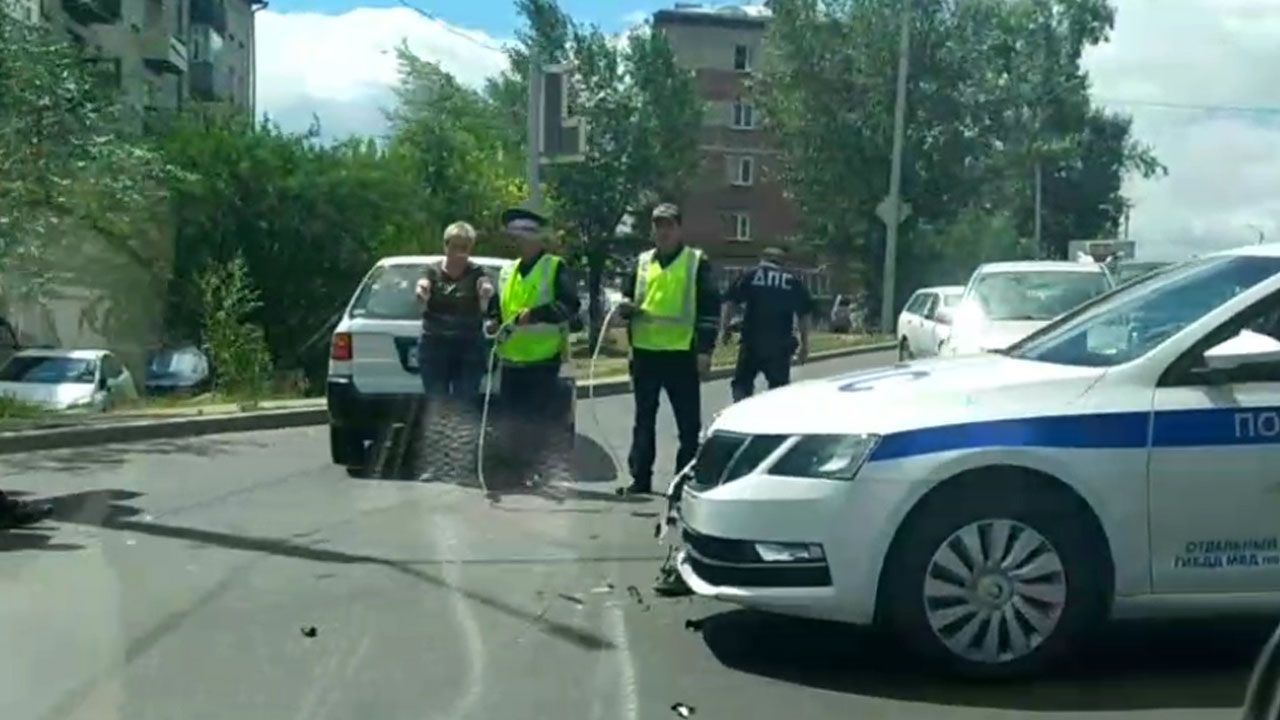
left=1007, top=256, right=1280, bottom=368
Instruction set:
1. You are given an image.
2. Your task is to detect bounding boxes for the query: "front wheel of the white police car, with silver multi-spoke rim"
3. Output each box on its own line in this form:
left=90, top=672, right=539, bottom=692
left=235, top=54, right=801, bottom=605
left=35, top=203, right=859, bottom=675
left=881, top=478, right=1110, bottom=679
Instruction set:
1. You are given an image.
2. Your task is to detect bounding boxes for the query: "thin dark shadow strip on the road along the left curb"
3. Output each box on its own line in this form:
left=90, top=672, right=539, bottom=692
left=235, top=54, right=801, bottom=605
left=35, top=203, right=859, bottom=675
left=0, top=436, right=266, bottom=473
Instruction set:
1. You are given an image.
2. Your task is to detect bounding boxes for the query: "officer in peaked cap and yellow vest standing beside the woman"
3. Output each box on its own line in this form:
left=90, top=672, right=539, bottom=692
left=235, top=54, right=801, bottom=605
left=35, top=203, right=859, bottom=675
left=489, top=208, right=581, bottom=482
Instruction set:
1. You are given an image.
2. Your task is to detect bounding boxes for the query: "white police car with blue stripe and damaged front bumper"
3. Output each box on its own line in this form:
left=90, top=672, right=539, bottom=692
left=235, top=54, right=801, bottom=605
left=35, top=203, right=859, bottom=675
left=678, top=245, right=1280, bottom=676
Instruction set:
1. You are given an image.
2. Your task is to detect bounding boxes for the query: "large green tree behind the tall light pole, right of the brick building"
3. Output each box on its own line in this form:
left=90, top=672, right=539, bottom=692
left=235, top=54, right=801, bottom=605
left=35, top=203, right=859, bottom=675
left=755, top=0, right=1158, bottom=322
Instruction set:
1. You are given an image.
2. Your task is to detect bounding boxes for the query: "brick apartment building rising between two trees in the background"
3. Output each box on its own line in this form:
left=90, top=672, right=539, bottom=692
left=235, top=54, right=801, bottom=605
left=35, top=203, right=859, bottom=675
left=653, top=3, right=828, bottom=295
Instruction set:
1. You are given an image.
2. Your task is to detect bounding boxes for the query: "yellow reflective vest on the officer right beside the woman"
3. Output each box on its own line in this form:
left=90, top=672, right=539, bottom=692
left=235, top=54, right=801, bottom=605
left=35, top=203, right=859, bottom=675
left=498, top=254, right=568, bottom=365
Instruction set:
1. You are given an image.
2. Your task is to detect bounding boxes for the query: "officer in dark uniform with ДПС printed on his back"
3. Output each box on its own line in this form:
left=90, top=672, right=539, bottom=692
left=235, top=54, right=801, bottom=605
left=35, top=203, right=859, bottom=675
left=723, top=247, right=813, bottom=402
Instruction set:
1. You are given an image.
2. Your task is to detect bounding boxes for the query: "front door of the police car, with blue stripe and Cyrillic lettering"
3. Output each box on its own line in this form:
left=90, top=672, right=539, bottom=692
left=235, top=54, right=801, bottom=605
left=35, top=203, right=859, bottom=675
left=1149, top=296, right=1280, bottom=593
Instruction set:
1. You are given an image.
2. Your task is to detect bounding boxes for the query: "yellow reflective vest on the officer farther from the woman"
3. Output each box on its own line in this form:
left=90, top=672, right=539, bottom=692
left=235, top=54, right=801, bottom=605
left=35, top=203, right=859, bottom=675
left=631, top=247, right=703, bottom=350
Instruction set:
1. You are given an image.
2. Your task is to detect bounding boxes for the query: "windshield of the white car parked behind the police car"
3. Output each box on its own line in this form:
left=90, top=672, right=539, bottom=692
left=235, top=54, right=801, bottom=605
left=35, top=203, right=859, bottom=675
left=972, top=270, right=1110, bottom=322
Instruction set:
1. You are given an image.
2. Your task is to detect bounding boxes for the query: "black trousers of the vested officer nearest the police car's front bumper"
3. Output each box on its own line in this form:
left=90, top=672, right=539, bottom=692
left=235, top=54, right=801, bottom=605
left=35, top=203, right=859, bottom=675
left=627, top=350, right=703, bottom=489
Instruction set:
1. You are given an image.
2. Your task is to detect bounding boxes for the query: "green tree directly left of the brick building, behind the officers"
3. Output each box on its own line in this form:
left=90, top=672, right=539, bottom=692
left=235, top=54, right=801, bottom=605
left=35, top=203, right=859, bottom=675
left=488, top=0, right=701, bottom=337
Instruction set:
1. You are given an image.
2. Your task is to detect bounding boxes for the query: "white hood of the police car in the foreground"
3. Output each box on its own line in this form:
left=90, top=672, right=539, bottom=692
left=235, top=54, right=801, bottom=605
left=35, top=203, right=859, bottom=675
left=712, top=355, right=1105, bottom=434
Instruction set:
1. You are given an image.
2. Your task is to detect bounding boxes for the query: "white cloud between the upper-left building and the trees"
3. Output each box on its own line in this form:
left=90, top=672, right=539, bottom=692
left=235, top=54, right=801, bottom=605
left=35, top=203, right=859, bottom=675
left=257, top=8, right=507, bottom=137
